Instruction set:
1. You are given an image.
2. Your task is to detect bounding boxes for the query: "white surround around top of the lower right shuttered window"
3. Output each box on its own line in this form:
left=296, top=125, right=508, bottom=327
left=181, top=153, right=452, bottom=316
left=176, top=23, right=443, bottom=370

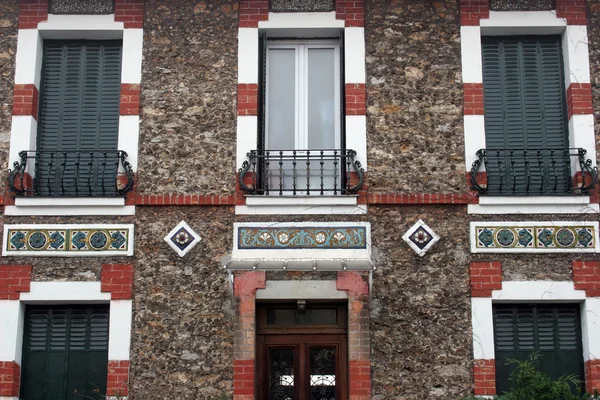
left=471, top=281, right=600, bottom=361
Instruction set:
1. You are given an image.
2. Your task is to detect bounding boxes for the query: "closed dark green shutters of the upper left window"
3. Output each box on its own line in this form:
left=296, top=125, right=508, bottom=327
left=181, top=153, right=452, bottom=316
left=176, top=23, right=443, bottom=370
left=36, top=41, right=122, bottom=196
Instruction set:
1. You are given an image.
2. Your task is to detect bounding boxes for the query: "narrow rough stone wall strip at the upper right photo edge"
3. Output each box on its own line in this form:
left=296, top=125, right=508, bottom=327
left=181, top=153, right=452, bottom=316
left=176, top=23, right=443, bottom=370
left=587, top=0, right=600, bottom=164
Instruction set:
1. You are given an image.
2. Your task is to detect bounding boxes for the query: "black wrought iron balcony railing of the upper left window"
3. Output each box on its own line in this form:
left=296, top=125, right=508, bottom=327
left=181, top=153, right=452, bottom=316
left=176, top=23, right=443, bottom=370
left=8, top=150, right=133, bottom=197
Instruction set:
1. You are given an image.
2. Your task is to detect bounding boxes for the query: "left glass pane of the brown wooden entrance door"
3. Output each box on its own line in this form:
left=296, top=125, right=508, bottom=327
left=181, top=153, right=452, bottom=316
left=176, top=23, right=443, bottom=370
left=268, top=349, right=294, bottom=400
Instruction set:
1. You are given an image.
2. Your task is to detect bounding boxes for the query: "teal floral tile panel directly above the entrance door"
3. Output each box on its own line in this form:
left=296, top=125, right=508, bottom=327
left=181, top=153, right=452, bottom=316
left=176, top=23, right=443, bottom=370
left=238, top=226, right=367, bottom=250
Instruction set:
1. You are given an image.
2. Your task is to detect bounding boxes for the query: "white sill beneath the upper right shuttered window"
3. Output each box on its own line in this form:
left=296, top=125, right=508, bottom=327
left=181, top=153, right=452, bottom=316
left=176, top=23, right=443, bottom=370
left=468, top=196, right=600, bottom=214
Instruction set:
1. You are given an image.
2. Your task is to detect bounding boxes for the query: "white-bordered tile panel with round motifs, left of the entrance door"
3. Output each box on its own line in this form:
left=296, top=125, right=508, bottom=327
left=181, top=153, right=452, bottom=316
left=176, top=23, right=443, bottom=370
left=2, top=224, right=133, bottom=257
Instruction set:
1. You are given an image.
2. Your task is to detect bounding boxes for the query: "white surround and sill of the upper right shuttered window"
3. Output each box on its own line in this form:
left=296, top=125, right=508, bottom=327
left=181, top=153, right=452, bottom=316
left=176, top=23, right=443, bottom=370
left=461, top=11, right=600, bottom=214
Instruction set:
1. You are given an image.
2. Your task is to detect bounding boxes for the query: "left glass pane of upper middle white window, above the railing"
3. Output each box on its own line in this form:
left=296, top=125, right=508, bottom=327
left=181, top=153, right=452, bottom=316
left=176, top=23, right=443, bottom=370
left=266, top=49, right=296, bottom=150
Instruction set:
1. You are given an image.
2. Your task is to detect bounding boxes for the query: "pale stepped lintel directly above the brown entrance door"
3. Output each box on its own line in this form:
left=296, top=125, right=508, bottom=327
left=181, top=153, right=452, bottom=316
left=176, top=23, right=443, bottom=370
left=256, top=280, right=348, bottom=300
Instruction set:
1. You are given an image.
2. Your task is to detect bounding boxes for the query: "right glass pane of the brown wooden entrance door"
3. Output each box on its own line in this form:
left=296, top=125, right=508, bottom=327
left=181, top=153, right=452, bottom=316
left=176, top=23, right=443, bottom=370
left=310, top=347, right=337, bottom=400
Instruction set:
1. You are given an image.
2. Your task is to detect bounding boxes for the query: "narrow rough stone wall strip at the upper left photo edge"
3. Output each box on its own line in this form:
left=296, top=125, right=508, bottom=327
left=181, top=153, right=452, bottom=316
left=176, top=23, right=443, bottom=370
left=0, top=0, right=19, bottom=171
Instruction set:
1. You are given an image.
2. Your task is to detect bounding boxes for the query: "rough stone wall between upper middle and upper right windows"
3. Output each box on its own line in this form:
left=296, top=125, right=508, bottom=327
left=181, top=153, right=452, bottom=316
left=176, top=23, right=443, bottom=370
left=365, top=0, right=467, bottom=193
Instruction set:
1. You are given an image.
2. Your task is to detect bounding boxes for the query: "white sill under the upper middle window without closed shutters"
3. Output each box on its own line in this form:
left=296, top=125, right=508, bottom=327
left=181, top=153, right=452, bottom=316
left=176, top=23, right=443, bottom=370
left=235, top=195, right=367, bottom=215
